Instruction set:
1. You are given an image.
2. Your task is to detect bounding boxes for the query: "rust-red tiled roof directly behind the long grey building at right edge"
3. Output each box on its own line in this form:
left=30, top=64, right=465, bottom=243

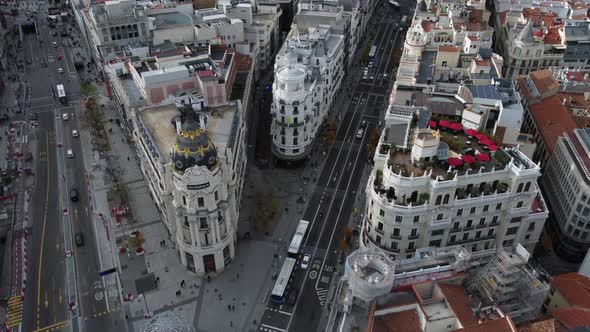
left=529, top=94, right=590, bottom=155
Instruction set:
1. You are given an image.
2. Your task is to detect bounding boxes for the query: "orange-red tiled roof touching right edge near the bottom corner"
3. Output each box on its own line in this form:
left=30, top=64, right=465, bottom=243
left=551, top=274, right=590, bottom=309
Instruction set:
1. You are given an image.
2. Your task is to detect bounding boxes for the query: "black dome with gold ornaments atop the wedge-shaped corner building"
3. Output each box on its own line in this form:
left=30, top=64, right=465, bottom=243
left=172, top=105, right=217, bottom=174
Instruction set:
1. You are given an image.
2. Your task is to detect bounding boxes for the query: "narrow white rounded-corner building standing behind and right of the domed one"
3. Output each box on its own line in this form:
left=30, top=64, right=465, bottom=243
left=271, top=25, right=344, bottom=161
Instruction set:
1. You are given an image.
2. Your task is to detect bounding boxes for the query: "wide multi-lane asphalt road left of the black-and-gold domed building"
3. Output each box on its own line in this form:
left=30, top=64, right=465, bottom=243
left=21, top=7, right=116, bottom=331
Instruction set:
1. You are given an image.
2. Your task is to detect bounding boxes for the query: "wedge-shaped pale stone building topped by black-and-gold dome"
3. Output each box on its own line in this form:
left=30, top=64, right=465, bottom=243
left=135, top=90, right=246, bottom=275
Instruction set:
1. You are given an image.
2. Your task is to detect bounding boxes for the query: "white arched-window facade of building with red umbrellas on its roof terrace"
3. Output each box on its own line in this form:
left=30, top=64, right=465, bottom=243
left=360, top=137, right=548, bottom=259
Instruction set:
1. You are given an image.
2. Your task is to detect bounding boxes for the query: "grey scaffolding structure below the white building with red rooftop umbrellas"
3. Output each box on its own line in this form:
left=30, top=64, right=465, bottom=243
left=466, top=245, right=550, bottom=324
